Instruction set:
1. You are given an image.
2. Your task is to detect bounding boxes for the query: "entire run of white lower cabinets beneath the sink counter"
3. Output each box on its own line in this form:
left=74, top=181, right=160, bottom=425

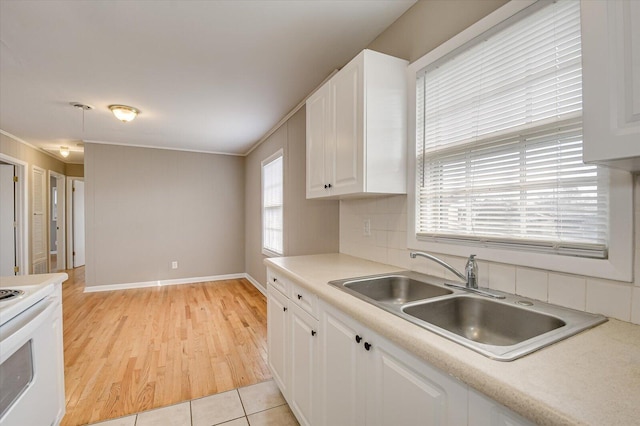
left=267, top=270, right=532, bottom=426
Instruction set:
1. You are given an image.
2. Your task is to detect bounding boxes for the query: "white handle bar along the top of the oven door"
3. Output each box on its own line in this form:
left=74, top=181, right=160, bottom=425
left=0, top=298, right=59, bottom=363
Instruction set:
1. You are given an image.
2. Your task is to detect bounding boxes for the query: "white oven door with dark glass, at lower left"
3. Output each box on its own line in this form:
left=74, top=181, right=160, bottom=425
left=0, top=298, right=64, bottom=426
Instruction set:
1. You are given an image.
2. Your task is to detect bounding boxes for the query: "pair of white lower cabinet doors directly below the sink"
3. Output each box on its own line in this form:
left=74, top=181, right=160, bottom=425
left=319, top=305, right=467, bottom=426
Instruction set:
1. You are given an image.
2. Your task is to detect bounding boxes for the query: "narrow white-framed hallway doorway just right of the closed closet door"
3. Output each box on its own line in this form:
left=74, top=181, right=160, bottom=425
left=49, top=171, right=66, bottom=272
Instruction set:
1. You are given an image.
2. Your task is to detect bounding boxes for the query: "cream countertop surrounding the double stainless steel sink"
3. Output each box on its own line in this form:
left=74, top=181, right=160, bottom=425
left=265, top=254, right=640, bottom=426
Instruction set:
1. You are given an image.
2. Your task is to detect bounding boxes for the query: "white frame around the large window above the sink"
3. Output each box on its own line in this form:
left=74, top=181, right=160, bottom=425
left=407, top=0, right=634, bottom=282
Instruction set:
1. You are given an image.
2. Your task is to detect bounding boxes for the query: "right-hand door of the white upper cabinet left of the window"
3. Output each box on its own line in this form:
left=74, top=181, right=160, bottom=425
left=331, top=54, right=365, bottom=195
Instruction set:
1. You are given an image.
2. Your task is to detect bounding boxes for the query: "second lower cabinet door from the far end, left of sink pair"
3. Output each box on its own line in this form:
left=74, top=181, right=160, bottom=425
left=289, top=305, right=318, bottom=425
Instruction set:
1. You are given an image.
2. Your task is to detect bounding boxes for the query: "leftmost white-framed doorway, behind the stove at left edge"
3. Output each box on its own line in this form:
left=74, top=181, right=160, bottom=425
left=0, top=154, right=29, bottom=276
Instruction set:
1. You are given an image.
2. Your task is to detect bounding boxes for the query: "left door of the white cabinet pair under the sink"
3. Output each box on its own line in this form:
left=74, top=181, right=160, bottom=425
left=318, top=304, right=366, bottom=426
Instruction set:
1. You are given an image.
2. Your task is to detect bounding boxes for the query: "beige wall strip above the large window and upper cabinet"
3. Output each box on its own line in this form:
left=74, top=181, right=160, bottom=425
left=367, top=0, right=508, bottom=62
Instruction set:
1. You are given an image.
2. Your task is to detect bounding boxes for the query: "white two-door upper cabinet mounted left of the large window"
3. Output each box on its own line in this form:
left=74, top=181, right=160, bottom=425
left=306, top=50, right=407, bottom=198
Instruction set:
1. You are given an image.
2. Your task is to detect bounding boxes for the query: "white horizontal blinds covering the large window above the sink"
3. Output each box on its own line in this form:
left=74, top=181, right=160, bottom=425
left=416, top=1, right=608, bottom=257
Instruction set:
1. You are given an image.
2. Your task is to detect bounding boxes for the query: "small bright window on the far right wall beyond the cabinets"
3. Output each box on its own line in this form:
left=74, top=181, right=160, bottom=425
left=262, top=150, right=284, bottom=256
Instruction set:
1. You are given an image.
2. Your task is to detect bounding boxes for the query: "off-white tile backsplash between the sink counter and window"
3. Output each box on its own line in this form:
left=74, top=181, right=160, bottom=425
left=340, top=176, right=640, bottom=324
